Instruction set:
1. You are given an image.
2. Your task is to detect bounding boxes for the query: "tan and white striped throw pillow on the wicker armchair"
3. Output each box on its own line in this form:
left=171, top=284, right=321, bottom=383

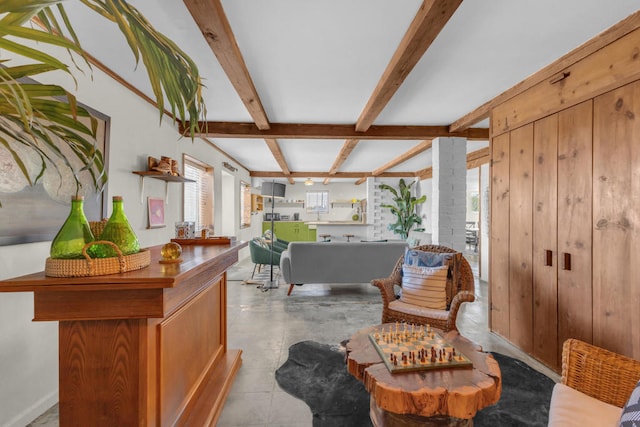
left=400, top=265, right=449, bottom=310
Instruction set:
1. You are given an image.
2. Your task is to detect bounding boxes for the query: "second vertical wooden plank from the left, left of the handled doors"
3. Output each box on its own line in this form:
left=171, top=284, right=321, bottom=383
left=509, top=124, right=533, bottom=353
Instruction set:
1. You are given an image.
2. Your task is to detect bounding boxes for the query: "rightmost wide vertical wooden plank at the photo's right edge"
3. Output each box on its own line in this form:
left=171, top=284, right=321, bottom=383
left=593, top=82, right=640, bottom=359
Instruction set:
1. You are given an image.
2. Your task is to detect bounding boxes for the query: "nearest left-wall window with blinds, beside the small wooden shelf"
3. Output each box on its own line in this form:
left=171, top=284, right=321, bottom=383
left=183, top=155, right=213, bottom=231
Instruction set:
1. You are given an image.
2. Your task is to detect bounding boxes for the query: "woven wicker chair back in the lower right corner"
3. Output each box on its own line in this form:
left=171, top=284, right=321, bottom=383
left=562, top=339, right=640, bottom=408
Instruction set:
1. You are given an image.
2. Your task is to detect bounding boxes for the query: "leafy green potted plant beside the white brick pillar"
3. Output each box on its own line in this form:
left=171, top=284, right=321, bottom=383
left=380, top=179, right=427, bottom=239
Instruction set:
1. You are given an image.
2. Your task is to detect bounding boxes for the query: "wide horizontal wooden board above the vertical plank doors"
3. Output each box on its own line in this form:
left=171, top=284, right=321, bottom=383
left=491, top=29, right=640, bottom=135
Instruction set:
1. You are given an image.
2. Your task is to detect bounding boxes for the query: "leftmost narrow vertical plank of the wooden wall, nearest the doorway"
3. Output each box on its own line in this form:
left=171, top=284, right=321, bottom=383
left=489, top=134, right=509, bottom=338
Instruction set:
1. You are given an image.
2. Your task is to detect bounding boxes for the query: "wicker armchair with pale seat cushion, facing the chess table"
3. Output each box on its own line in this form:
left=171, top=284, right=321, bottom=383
left=371, top=245, right=475, bottom=332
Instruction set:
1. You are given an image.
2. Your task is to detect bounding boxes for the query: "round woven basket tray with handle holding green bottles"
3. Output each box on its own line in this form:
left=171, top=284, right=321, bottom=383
left=44, top=240, right=151, bottom=277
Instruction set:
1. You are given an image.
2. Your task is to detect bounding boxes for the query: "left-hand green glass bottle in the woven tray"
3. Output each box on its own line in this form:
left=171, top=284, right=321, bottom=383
left=49, top=196, right=94, bottom=259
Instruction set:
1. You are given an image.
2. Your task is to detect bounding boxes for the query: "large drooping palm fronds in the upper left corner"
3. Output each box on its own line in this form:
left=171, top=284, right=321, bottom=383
left=0, top=0, right=205, bottom=206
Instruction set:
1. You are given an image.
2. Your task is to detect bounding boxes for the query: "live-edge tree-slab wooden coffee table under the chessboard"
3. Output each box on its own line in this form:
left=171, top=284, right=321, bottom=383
left=347, top=324, right=502, bottom=427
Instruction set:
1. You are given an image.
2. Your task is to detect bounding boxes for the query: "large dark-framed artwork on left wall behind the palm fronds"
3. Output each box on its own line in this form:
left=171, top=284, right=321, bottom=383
left=0, top=105, right=110, bottom=246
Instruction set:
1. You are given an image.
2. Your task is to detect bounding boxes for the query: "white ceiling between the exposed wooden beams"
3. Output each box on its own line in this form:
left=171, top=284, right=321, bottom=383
left=66, top=0, right=638, bottom=186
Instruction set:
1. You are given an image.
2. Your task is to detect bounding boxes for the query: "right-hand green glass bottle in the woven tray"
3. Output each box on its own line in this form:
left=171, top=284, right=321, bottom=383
left=90, top=196, right=140, bottom=258
